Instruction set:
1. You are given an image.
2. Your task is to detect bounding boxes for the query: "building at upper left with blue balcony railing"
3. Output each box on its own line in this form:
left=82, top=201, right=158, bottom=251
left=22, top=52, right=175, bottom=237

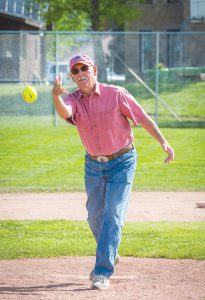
left=0, top=0, right=44, bottom=82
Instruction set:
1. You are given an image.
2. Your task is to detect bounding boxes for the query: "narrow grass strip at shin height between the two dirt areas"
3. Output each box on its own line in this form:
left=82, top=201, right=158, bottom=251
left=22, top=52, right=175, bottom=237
left=0, top=220, right=205, bottom=259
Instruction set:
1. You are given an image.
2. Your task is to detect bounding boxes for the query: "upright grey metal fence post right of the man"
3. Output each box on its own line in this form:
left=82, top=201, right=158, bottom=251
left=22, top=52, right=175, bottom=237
left=155, top=32, right=160, bottom=124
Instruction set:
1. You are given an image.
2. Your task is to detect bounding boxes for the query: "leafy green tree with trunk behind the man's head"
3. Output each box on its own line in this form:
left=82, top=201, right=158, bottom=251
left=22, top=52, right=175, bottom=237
left=37, top=0, right=140, bottom=80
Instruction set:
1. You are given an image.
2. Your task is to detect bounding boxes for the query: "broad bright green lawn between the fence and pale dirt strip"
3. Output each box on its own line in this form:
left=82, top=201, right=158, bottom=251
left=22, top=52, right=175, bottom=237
left=0, top=123, right=205, bottom=192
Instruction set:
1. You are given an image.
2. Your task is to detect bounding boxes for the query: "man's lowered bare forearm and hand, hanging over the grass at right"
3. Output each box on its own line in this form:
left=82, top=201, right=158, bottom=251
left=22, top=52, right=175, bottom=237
left=140, top=113, right=174, bottom=164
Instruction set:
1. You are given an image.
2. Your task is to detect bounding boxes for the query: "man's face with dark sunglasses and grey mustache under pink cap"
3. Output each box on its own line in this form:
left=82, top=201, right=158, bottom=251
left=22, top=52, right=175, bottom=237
left=70, top=63, right=97, bottom=95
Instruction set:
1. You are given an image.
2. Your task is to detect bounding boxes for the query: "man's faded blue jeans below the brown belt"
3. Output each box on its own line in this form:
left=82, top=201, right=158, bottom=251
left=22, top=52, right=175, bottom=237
left=85, top=149, right=137, bottom=277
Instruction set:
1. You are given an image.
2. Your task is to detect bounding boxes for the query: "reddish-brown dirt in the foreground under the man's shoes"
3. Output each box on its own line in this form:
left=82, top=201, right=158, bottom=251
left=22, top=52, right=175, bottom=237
left=0, top=257, right=205, bottom=300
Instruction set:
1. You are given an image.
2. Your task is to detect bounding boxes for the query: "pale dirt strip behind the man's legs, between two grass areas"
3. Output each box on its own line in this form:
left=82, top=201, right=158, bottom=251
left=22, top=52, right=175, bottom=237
left=0, top=192, right=205, bottom=221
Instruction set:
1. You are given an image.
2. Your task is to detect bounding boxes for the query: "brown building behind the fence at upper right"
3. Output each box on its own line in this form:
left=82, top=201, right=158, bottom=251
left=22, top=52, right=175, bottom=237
left=125, top=0, right=205, bottom=74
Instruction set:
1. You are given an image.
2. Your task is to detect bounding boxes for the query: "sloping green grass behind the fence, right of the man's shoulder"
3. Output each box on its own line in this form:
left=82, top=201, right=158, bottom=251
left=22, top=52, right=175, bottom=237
left=124, top=81, right=205, bottom=128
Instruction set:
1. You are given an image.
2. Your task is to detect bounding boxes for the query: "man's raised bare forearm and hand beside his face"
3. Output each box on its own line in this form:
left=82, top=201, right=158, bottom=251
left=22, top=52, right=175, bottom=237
left=52, top=75, right=72, bottom=119
